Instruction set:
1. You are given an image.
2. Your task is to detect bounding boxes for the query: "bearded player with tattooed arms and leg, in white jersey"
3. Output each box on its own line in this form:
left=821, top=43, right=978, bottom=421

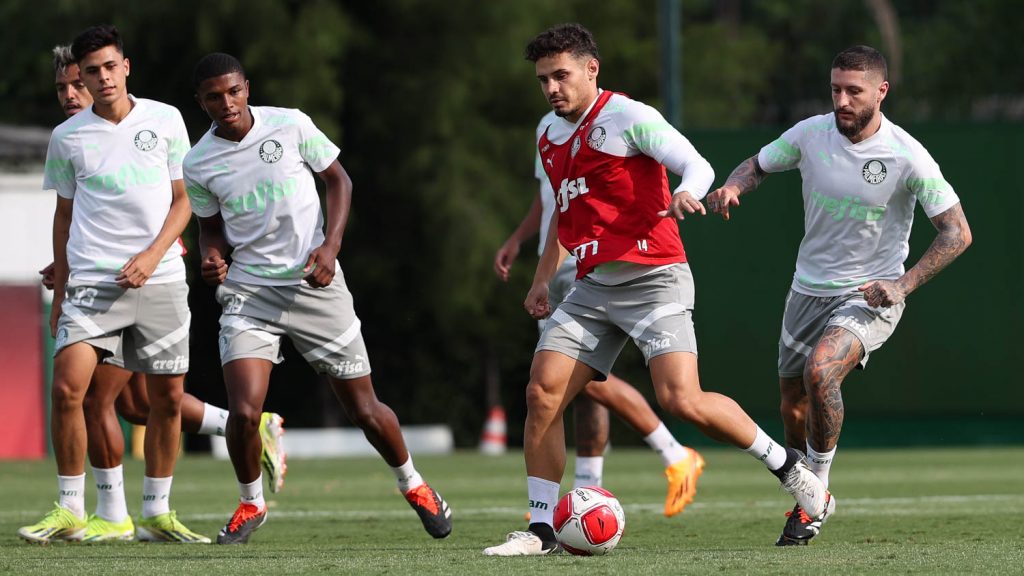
left=708, top=46, right=971, bottom=546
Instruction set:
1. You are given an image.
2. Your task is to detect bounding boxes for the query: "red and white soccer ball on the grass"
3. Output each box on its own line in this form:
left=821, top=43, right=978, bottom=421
left=555, top=486, right=626, bottom=556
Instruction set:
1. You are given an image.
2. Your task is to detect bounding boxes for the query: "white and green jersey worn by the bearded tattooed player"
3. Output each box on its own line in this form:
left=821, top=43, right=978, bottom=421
left=758, top=113, right=959, bottom=296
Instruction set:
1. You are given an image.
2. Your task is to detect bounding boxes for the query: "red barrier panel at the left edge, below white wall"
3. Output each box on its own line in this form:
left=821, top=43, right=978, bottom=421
left=0, top=285, right=46, bottom=459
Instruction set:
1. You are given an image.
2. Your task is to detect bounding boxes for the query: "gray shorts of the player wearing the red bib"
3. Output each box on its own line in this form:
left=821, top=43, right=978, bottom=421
left=537, top=264, right=697, bottom=379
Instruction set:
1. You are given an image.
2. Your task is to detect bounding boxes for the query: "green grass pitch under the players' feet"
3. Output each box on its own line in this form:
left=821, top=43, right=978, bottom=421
left=0, top=448, right=1024, bottom=576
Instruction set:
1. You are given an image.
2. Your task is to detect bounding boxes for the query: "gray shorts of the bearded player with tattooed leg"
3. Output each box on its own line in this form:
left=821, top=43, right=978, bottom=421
left=778, top=290, right=906, bottom=378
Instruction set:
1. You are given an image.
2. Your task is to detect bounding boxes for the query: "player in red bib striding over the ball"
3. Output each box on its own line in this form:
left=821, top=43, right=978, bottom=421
left=483, top=24, right=836, bottom=556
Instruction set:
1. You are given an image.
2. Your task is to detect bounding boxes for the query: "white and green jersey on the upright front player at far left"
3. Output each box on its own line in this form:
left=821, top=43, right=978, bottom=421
left=43, top=96, right=188, bottom=284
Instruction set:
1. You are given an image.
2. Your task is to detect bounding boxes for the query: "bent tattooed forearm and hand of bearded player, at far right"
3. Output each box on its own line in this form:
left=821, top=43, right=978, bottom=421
left=859, top=203, right=972, bottom=306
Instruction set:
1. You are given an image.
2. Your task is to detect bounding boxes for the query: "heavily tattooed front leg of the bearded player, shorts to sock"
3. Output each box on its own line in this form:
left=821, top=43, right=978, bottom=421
left=804, top=327, right=864, bottom=452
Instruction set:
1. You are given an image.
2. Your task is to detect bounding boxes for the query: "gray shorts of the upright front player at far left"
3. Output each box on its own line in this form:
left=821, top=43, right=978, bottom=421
left=54, top=281, right=191, bottom=374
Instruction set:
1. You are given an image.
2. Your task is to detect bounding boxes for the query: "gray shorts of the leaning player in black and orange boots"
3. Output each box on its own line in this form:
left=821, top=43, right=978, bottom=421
left=217, top=269, right=370, bottom=379
